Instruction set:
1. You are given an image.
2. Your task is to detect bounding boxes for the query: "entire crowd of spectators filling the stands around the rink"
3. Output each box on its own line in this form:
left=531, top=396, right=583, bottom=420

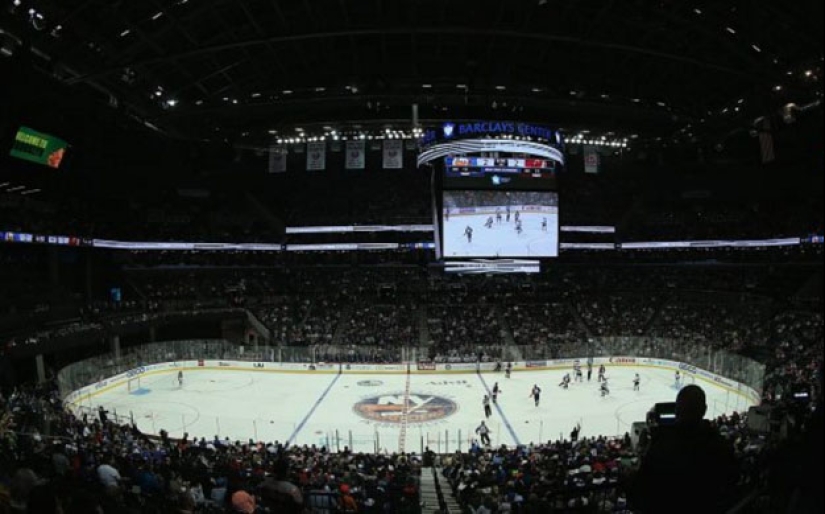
left=0, top=258, right=825, bottom=514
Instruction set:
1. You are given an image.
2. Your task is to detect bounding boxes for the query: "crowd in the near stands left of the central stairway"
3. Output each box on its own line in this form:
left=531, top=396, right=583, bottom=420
left=0, top=386, right=422, bottom=514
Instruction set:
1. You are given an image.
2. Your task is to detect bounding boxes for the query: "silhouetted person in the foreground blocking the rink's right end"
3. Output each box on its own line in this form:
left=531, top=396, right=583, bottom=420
left=632, top=385, right=738, bottom=514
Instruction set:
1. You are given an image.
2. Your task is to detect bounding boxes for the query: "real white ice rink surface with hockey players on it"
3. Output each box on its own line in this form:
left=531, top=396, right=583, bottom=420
left=77, top=367, right=749, bottom=452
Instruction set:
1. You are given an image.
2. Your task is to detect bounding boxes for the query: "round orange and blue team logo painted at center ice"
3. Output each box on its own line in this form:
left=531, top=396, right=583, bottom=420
left=353, top=394, right=458, bottom=424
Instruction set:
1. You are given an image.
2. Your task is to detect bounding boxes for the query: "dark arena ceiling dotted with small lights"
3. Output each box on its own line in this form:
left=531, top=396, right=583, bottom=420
left=0, top=0, right=823, bottom=146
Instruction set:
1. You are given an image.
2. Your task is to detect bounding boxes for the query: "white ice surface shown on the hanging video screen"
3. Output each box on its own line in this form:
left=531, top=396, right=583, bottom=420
left=444, top=212, right=559, bottom=257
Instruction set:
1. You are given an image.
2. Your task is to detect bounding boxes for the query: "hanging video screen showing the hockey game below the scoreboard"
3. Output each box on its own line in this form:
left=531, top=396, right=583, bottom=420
left=442, top=191, right=559, bottom=258
